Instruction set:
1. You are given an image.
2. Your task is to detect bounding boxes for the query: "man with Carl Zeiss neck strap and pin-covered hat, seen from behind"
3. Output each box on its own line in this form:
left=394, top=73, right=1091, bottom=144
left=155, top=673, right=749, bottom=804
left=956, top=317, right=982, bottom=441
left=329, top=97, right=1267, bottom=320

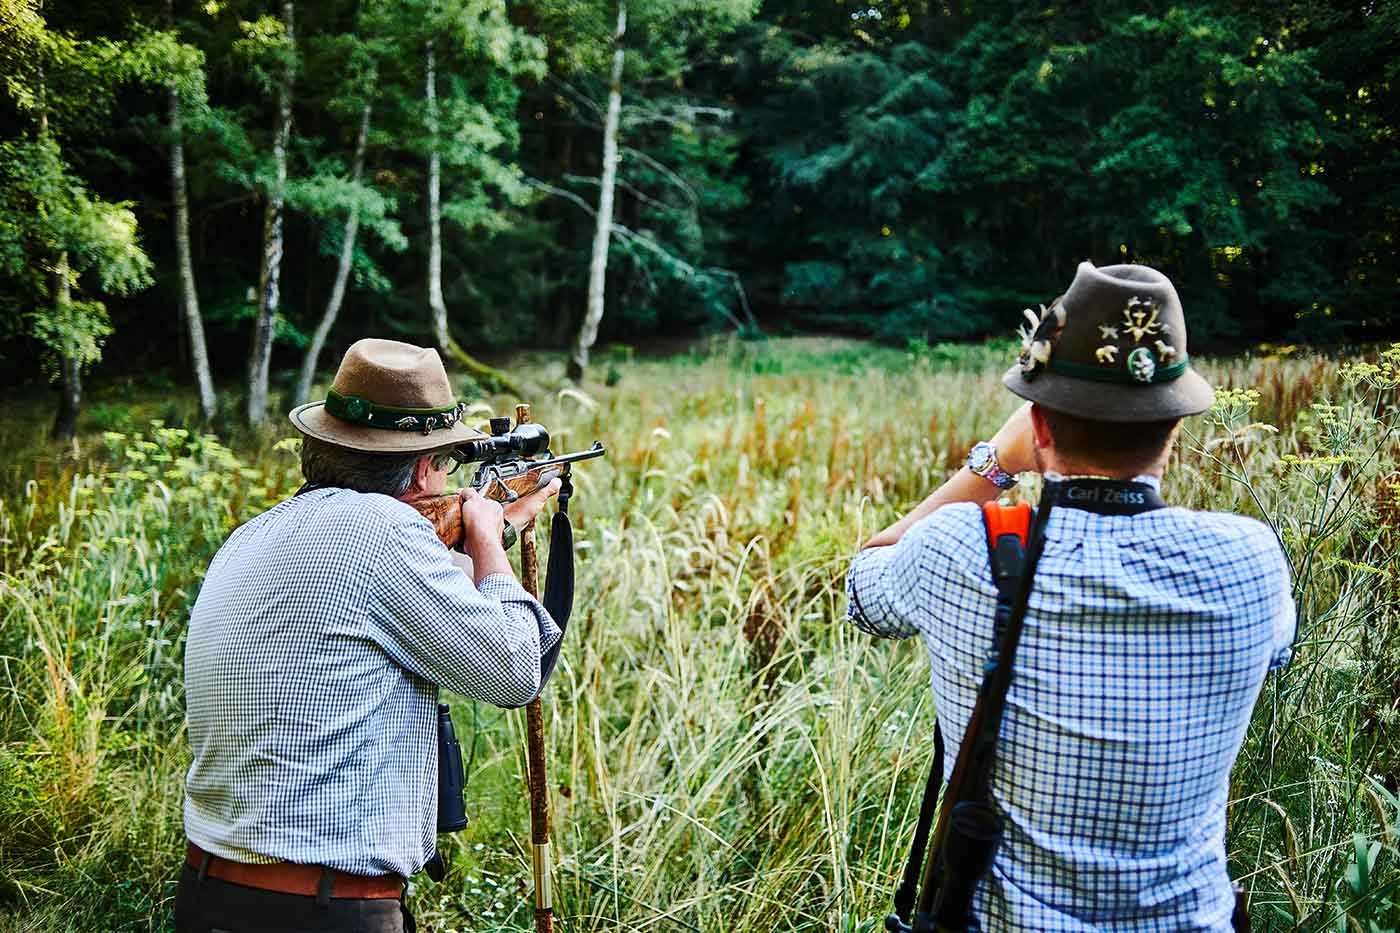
left=847, top=262, right=1295, bottom=933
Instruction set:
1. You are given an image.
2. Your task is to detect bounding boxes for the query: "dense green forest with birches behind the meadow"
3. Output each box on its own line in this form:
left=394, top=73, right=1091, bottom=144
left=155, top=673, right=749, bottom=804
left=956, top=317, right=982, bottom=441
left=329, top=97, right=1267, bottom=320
left=0, top=0, right=1400, bottom=434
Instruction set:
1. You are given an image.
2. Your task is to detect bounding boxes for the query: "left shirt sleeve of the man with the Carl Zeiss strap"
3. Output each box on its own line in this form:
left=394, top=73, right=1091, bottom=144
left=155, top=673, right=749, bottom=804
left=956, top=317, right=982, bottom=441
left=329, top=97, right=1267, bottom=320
left=846, top=513, right=938, bottom=639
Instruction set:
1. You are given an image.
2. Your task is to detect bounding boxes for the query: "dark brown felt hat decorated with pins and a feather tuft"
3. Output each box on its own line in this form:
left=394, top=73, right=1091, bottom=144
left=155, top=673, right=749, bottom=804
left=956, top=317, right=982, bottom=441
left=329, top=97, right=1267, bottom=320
left=1001, top=262, right=1215, bottom=422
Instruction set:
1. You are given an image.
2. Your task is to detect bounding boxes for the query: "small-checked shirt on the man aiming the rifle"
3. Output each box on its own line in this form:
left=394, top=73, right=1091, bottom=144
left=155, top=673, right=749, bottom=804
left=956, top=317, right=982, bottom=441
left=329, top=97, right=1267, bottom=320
left=185, top=489, right=560, bottom=877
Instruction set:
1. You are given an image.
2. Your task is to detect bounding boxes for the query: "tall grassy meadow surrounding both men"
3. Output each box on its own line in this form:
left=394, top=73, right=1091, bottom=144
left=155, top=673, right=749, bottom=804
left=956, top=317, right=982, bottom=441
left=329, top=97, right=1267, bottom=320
left=0, top=339, right=1400, bottom=933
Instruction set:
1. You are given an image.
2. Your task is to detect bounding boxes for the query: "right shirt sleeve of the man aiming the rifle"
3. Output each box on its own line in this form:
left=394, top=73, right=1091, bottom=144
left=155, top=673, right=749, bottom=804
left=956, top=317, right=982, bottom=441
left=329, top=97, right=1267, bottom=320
left=370, top=509, right=561, bottom=706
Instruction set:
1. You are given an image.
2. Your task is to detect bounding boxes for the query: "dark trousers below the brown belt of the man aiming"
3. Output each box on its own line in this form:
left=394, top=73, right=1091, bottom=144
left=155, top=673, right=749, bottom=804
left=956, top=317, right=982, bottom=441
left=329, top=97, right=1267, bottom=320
left=175, top=866, right=414, bottom=933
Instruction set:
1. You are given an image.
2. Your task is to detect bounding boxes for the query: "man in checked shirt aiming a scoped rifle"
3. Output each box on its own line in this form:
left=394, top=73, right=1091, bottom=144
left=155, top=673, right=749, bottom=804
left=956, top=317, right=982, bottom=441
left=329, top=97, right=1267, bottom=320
left=175, top=339, right=560, bottom=933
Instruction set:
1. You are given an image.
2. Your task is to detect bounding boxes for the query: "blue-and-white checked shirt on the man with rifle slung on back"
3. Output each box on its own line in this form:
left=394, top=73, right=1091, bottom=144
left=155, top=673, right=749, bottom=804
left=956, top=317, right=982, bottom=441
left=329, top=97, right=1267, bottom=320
left=847, top=490, right=1295, bottom=933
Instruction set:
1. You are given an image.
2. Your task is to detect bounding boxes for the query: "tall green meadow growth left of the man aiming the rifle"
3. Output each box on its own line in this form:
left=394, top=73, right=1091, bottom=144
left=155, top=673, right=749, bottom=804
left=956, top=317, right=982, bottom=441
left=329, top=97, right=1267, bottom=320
left=0, top=422, right=294, bottom=930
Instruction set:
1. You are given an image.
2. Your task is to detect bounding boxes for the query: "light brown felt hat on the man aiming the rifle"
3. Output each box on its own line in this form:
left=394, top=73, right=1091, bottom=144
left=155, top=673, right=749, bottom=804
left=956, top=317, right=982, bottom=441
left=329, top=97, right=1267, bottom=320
left=287, top=338, right=484, bottom=454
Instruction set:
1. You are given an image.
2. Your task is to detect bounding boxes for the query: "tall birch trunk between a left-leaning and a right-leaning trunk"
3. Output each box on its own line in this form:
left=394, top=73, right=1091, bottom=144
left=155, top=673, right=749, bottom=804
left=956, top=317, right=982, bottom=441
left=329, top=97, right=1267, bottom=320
left=248, top=0, right=297, bottom=427
